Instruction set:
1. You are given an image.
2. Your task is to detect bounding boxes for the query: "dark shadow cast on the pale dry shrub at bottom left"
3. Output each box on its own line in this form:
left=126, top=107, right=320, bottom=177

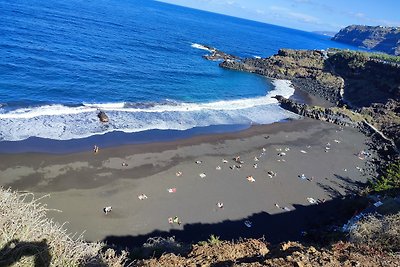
left=0, top=239, right=51, bottom=267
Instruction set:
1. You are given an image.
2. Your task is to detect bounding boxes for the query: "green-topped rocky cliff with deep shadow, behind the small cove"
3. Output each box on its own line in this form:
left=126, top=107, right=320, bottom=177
left=220, top=49, right=400, bottom=108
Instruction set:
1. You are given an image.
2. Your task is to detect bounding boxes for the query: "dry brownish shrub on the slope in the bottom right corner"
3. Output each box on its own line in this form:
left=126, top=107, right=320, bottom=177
left=350, top=212, right=400, bottom=252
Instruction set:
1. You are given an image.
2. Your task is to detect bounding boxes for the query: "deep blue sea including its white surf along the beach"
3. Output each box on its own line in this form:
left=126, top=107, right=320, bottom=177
left=0, top=0, right=356, bottom=141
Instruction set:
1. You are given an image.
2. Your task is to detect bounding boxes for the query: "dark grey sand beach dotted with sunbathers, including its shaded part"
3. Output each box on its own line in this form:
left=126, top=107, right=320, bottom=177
left=0, top=119, right=374, bottom=248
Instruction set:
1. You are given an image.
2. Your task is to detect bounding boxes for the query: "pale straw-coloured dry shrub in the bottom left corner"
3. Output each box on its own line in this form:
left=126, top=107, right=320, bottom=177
left=0, top=188, right=127, bottom=267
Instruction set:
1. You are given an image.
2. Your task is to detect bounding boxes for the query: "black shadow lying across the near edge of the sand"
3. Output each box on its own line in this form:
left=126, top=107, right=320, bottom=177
left=103, top=198, right=365, bottom=256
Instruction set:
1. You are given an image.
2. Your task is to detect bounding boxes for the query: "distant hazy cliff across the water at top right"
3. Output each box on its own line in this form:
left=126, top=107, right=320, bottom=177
left=332, top=25, right=400, bottom=55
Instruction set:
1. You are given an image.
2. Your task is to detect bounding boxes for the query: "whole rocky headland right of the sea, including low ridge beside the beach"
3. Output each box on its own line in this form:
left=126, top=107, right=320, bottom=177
left=203, top=46, right=400, bottom=163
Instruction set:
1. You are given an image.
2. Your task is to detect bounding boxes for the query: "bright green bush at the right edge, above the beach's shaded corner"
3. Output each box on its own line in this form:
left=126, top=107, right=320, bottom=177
left=370, top=160, right=400, bottom=192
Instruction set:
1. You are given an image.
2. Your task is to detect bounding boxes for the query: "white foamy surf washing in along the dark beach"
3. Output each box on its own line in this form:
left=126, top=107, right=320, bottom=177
left=0, top=80, right=296, bottom=141
